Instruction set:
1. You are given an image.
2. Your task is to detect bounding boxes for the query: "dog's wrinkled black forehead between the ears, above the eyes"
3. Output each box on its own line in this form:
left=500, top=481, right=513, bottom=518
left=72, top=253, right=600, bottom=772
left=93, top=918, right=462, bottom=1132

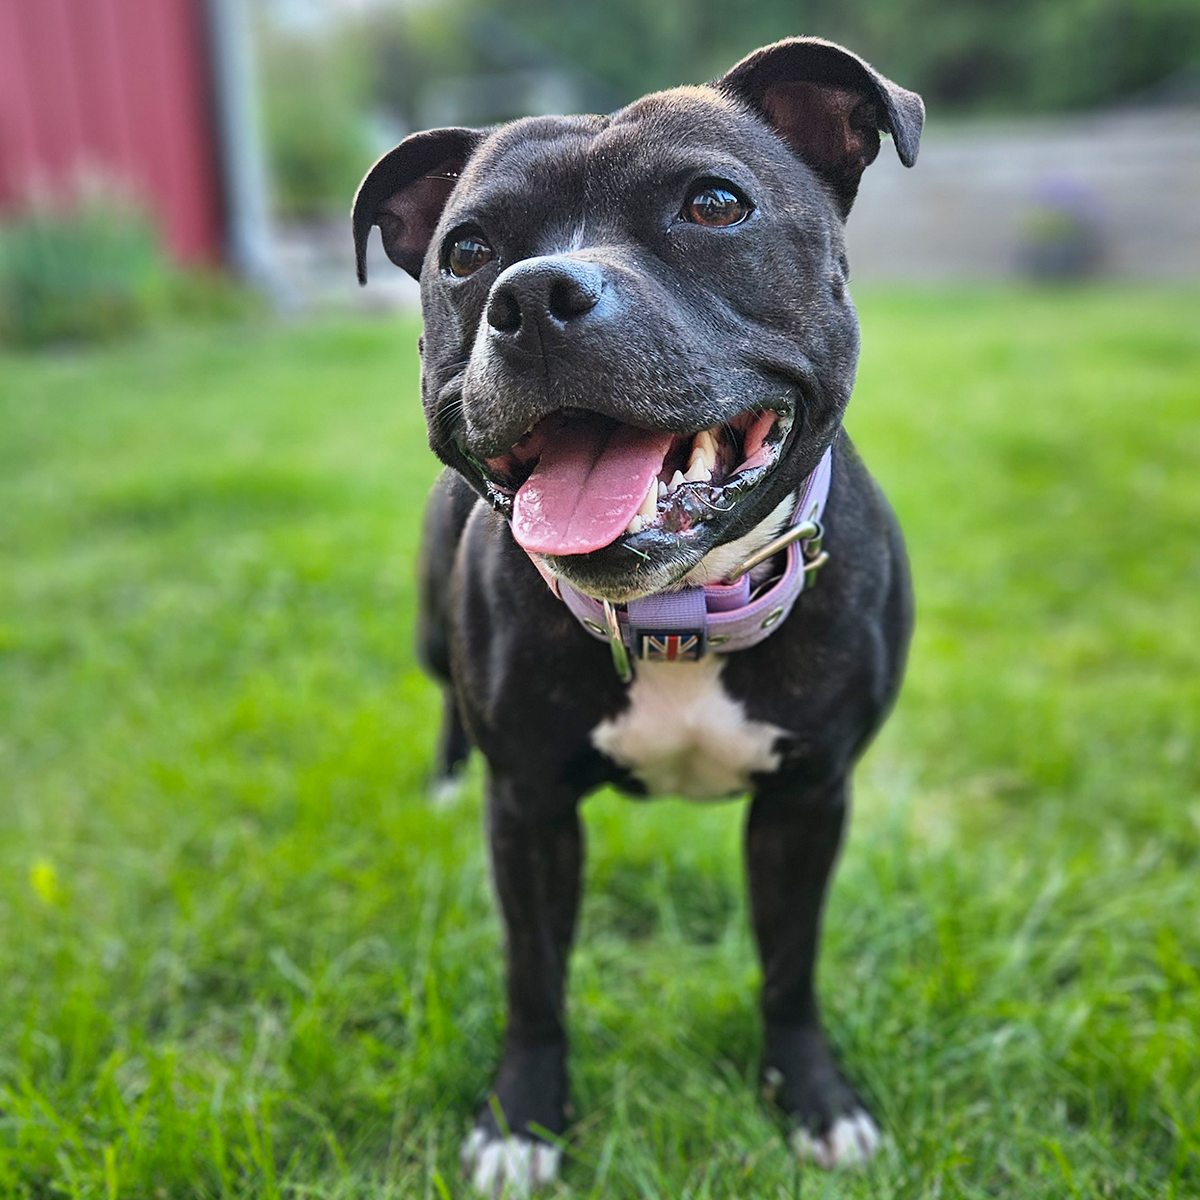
left=444, top=88, right=774, bottom=226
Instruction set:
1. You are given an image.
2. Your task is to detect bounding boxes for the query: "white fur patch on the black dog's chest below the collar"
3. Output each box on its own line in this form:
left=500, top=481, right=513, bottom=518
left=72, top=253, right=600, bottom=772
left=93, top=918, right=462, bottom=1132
left=592, top=655, right=784, bottom=799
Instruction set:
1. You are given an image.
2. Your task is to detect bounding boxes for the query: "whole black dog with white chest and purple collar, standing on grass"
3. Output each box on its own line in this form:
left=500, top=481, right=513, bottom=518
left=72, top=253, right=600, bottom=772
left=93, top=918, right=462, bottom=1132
left=354, top=38, right=924, bottom=1194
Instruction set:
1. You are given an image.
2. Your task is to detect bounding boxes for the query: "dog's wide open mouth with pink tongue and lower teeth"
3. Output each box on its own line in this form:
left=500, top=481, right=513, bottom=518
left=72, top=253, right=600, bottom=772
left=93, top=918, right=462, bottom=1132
left=478, top=409, right=792, bottom=556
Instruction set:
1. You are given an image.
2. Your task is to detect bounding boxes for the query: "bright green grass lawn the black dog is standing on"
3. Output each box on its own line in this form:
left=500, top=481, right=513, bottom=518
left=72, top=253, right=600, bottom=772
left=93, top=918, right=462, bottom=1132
left=0, top=288, right=1200, bottom=1200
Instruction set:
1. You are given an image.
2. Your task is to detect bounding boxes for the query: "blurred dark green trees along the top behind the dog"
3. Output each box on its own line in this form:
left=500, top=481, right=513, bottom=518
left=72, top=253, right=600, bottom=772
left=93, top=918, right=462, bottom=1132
left=374, top=0, right=1200, bottom=112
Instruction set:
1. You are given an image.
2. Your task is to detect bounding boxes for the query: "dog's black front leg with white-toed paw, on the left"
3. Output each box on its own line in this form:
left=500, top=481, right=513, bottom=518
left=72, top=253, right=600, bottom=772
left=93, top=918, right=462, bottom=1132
left=463, top=774, right=583, bottom=1196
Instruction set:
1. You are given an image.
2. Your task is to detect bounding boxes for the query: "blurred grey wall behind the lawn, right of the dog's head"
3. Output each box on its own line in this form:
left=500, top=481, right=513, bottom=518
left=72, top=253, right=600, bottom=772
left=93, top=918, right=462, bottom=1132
left=848, top=108, right=1200, bottom=280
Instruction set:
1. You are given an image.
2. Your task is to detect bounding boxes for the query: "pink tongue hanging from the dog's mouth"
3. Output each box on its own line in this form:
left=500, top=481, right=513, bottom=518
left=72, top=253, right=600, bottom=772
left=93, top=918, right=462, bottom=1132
left=512, top=421, right=671, bottom=554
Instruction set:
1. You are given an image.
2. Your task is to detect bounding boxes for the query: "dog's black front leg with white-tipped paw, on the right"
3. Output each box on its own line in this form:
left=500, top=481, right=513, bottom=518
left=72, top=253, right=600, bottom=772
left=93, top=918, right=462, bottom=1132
left=746, top=779, right=880, bottom=1168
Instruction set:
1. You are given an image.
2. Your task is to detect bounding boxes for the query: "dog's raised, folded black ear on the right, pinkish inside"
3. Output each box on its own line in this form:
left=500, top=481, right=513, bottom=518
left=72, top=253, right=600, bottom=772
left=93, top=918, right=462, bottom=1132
left=715, top=37, right=925, bottom=217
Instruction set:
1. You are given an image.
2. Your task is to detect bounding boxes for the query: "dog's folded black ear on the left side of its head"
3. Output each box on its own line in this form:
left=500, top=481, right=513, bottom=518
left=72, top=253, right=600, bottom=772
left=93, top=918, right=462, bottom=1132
left=350, top=128, right=484, bottom=283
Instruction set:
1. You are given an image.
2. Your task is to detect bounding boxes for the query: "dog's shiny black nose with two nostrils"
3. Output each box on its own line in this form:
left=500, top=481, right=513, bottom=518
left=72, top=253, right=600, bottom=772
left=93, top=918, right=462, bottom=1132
left=487, top=254, right=604, bottom=349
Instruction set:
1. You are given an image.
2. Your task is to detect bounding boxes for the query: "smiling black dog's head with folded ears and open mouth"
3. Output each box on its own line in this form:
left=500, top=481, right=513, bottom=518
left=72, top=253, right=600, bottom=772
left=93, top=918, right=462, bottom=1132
left=353, top=38, right=924, bottom=600
